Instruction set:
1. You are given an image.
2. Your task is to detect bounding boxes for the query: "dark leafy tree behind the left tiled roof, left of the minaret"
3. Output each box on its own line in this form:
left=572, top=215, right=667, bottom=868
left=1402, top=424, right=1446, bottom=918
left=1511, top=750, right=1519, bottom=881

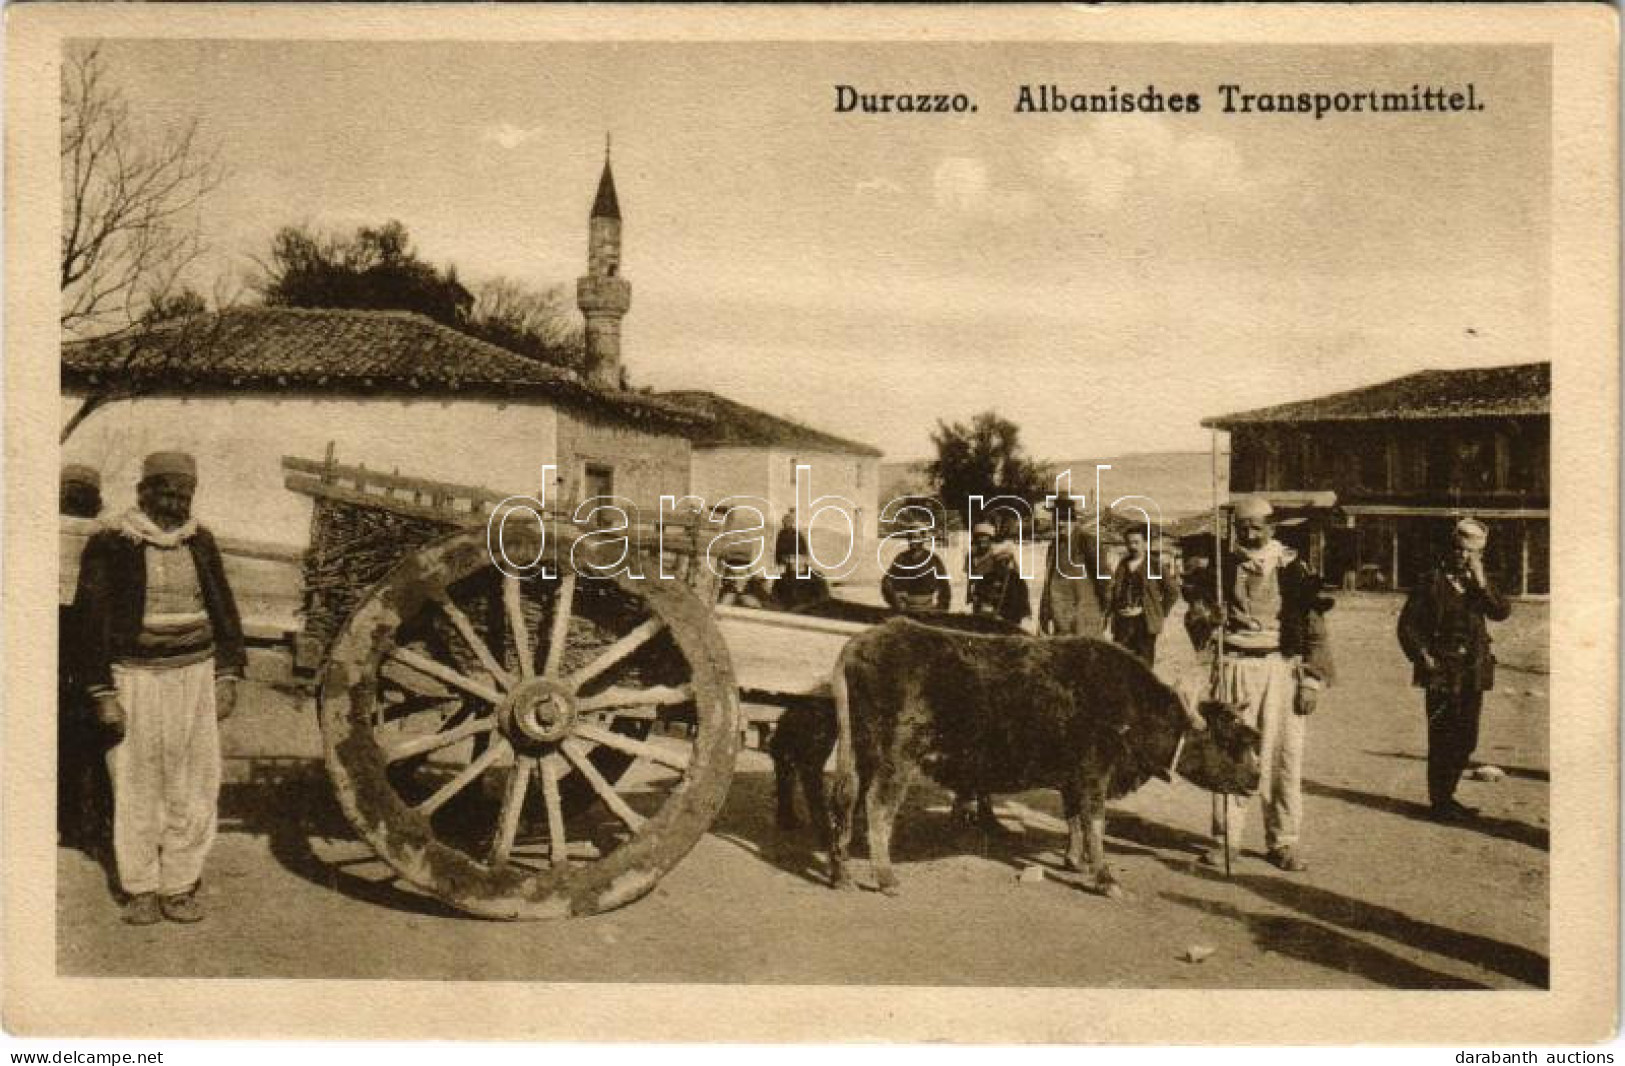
left=258, top=221, right=475, bottom=327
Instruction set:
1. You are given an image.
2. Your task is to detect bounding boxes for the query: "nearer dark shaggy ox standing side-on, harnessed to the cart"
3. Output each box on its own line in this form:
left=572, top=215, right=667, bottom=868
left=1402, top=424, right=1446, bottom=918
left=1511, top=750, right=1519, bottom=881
left=798, top=619, right=1258, bottom=899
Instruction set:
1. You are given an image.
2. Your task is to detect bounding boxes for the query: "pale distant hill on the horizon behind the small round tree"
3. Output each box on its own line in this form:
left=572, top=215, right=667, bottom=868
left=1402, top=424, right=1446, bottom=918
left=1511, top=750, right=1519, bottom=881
left=881, top=452, right=1230, bottom=522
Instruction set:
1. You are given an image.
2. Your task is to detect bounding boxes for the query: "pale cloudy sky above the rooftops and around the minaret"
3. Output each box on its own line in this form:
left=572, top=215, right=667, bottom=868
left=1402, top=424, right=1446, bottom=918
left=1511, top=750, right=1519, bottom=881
left=95, top=41, right=1550, bottom=460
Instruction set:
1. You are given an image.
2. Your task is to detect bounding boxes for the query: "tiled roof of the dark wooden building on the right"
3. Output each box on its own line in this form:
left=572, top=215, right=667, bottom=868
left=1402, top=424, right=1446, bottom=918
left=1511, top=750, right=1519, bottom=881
left=1203, top=362, right=1552, bottom=429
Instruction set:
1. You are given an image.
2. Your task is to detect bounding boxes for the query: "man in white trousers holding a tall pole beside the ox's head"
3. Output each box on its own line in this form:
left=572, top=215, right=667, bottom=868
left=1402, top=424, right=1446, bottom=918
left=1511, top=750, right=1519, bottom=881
left=1203, top=496, right=1333, bottom=873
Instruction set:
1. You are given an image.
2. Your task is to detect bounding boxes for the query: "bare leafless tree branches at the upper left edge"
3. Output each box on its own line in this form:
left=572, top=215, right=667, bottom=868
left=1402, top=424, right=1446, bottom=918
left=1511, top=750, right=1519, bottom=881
left=60, top=46, right=224, bottom=335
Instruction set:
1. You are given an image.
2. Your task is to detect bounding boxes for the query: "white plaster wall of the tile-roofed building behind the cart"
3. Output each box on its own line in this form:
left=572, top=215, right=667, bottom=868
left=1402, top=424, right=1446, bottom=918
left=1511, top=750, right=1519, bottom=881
left=62, top=393, right=557, bottom=548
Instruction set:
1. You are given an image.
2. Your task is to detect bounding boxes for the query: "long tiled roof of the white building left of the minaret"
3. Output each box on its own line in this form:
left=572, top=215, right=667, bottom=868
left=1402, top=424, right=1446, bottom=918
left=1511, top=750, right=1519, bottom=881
left=62, top=307, right=707, bottom=431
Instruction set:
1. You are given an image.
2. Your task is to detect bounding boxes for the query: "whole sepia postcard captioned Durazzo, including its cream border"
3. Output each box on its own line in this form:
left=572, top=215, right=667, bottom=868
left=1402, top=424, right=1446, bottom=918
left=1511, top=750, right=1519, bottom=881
left=7, top=5, right=1619, bottom=1042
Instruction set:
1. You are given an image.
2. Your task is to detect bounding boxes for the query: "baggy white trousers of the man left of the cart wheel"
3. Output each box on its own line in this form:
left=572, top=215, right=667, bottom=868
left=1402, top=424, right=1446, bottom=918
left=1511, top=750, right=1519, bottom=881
left=107, top=660, right=219, bottom=895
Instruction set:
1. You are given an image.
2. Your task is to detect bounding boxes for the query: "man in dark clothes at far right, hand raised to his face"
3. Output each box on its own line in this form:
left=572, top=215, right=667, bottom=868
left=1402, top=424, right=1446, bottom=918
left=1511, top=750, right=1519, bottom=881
left=1399, top=518, right=1511, bottom=822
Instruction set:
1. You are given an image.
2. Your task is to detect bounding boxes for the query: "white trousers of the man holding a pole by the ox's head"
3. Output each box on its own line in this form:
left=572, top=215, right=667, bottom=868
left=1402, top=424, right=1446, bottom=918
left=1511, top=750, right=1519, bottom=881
left=1212, top=655, right=1307, bottom=848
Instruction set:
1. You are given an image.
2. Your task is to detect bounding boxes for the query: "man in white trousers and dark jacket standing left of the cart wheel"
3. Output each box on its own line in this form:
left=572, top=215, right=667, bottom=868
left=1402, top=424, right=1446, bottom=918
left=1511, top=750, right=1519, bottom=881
left=75, top=452, right=245, bottom=925
